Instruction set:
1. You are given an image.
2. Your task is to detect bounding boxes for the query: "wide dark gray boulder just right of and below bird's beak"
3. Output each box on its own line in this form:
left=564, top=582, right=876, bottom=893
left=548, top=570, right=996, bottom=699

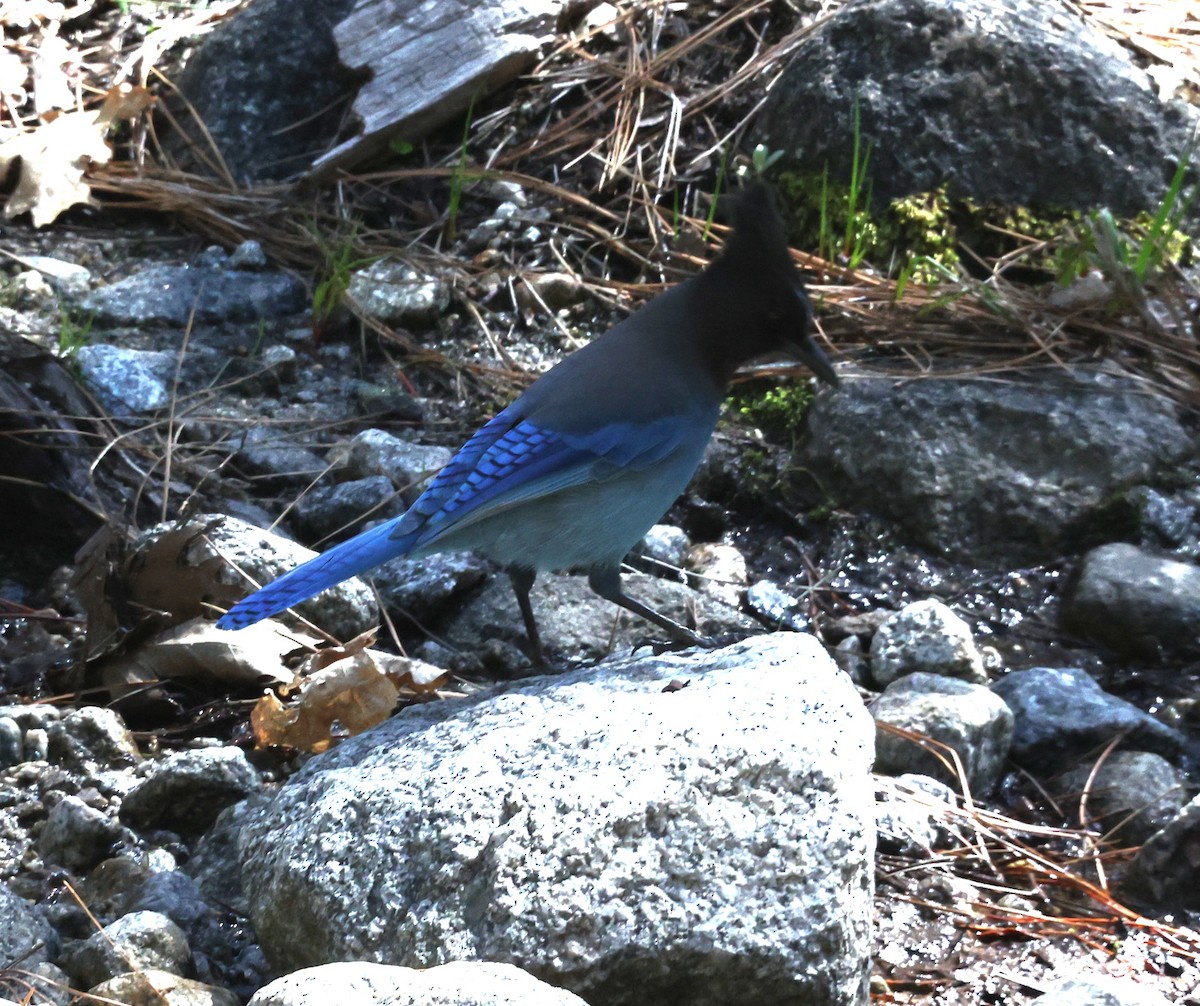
left=797, top=371, right=1195, bottom=563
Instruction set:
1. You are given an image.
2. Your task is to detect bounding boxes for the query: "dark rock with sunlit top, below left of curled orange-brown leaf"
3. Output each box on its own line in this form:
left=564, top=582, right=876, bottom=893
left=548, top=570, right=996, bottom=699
left=121, top=747, right=262, bottom=834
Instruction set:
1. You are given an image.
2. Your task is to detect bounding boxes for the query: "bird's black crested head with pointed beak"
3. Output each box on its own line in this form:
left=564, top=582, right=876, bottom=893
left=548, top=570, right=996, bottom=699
left=703, top=182, right=838, bottom=384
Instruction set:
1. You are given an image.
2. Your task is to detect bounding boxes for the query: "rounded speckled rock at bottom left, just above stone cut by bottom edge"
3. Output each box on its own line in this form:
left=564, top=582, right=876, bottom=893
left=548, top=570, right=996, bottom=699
left=61, top=911, right=192, bottom=988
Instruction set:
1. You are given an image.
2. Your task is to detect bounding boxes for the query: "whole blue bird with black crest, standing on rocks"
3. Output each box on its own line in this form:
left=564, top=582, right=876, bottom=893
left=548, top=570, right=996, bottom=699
left=217, top=184, right=838, bottom=663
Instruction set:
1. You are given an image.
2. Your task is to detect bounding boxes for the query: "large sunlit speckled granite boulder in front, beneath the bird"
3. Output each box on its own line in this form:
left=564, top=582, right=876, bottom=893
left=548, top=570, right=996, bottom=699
left=234, top=633, right=875, bottom=1006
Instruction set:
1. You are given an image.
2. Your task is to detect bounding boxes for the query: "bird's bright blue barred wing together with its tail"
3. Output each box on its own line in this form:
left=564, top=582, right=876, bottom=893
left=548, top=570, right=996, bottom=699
left=217, top=407, right=690, bottom=629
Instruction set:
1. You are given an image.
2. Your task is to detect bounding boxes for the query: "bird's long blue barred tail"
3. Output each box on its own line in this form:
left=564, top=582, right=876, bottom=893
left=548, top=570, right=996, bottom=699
left=217, top=521, right=412, bottom=629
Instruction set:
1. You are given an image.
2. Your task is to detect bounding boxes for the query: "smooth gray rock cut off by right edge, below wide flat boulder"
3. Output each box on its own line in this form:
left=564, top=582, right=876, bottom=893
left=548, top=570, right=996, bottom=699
left=1063, top=543, right=1200, bottom=655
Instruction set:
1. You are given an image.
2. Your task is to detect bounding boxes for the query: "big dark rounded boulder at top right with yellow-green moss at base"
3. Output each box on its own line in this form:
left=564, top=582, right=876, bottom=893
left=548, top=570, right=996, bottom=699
left=758, top=0, right=1189, bottom=215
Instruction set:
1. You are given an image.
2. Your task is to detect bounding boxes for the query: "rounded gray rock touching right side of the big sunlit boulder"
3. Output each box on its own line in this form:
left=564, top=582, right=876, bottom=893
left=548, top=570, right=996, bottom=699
left=871, top=672, right=1013, bottom=796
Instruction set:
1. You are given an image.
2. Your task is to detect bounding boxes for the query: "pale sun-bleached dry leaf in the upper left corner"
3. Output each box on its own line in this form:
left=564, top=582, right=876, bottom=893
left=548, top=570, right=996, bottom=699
left=0, top=88, right=152, bottom=227
